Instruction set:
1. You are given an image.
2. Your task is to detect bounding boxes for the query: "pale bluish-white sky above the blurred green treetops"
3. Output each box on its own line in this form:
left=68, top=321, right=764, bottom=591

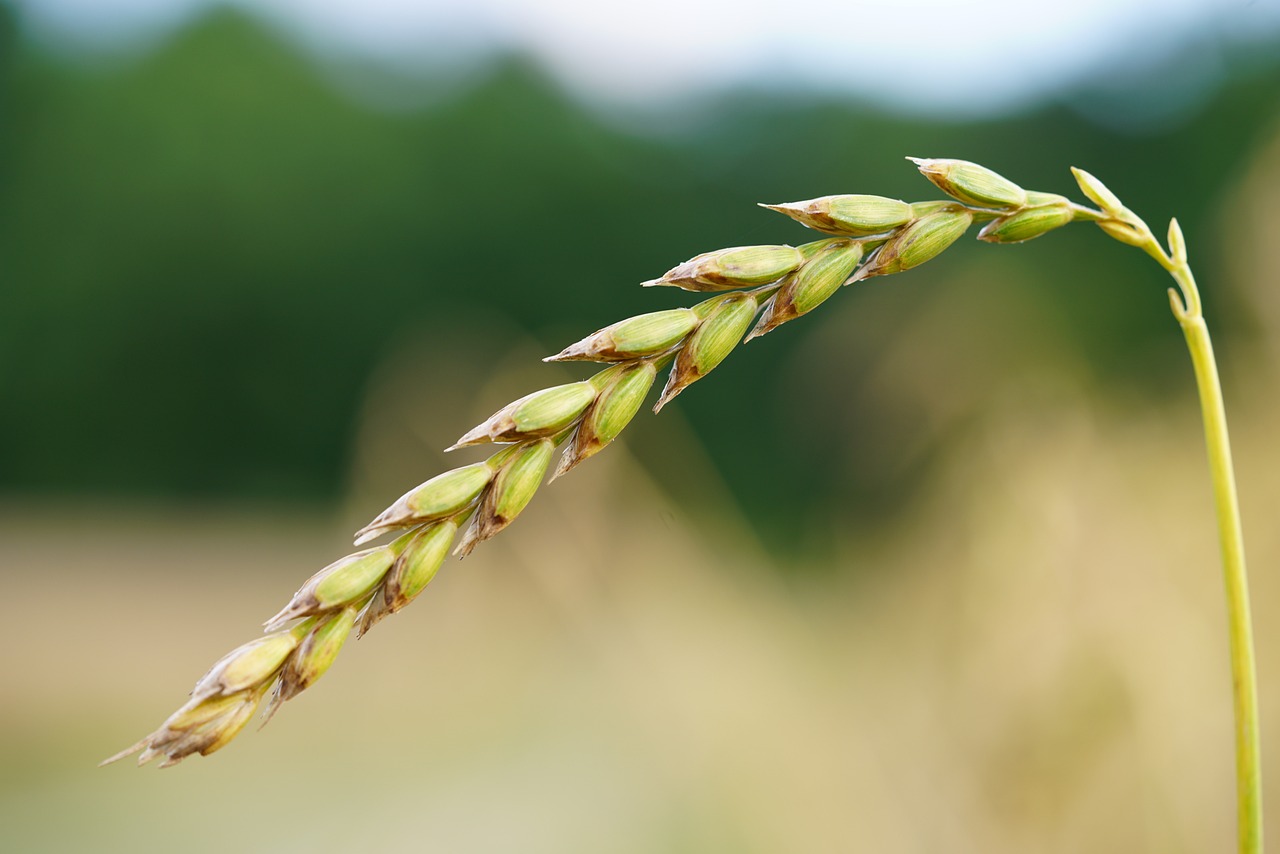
left=15, top=0, right=1280, bottom=113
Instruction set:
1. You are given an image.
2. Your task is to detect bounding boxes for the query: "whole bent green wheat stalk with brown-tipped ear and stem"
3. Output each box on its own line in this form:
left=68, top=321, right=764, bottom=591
left=104, top=157, right=1261, bottom=853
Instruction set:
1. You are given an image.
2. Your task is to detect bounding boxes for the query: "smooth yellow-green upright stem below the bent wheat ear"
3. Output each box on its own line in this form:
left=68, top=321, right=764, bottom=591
left=1170, top=284, right=1262, bottom=854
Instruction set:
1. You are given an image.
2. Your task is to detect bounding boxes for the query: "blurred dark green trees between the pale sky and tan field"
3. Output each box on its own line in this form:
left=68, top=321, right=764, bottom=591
left=0, top=6, right=1280, bottom=551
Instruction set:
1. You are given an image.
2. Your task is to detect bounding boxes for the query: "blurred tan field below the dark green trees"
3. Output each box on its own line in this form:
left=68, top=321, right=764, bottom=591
left=0, top=289, right=1280, bottom=853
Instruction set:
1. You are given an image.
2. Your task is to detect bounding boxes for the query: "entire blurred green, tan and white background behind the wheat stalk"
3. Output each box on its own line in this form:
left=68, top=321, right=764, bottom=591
left=0, top=0, right=1280, bottom=854
